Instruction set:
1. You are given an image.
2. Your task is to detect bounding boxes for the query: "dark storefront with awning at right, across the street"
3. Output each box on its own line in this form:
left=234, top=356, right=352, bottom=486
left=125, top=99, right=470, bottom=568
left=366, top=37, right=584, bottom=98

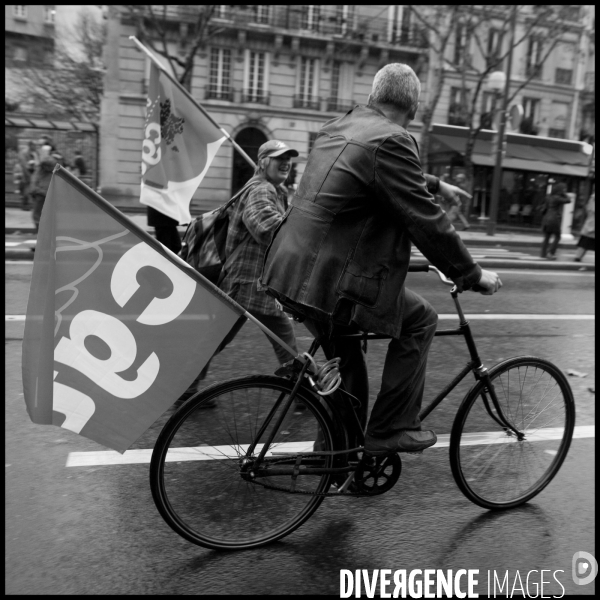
left=429, top=125, right=594, bottom=231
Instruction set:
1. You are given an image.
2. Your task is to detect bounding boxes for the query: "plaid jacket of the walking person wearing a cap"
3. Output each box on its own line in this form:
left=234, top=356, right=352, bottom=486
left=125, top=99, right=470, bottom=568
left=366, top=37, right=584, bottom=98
left=219, top=179, right=287, bottom=315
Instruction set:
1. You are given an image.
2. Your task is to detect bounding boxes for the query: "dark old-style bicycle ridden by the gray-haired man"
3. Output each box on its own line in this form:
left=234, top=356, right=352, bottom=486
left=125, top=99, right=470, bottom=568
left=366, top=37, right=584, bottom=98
left=150, top=265, right=575, bottom=550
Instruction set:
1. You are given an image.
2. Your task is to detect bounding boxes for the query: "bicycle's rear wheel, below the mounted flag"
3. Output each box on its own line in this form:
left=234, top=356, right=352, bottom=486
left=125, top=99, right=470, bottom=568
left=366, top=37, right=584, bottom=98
left=150, top=376, right=334, bottom=550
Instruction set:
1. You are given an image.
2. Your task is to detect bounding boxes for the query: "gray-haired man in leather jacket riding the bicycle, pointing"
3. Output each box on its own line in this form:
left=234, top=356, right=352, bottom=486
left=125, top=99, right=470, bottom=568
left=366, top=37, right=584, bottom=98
left=261, top=64, right=502, bottom=455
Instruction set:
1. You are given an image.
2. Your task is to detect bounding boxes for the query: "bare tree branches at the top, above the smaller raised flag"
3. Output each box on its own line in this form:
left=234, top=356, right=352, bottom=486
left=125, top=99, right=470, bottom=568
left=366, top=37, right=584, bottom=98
left=125, top=4, right=222, bottom=91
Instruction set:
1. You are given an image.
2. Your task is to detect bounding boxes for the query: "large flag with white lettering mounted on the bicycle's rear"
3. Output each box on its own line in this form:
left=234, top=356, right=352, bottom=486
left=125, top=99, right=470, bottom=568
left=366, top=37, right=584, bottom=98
left=22, top=167, right=245, bottom=452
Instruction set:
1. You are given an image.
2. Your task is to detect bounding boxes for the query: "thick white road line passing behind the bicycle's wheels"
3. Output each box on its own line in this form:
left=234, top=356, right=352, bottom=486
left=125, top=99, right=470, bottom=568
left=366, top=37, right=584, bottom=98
left=65, top=425, right=596, bottom=467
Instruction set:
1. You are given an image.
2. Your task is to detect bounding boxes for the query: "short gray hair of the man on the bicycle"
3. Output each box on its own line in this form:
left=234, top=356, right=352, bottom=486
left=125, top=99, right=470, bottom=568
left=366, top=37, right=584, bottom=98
left=370, top=63, right=421, bottom=112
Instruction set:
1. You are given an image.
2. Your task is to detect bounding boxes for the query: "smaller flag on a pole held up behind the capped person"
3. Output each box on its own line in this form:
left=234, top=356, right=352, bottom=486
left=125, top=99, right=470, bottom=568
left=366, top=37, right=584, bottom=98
left=140, top=62, right=225, bottom=224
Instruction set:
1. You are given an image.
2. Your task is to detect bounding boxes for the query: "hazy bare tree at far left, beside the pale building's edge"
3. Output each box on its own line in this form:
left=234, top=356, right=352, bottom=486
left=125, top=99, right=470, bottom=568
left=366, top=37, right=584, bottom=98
left=19, top=12, right=106, bottom=123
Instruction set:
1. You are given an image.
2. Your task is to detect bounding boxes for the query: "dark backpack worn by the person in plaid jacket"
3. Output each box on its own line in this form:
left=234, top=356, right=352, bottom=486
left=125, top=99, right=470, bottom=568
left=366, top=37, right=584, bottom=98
left=179, top=178, right=261, bottom=285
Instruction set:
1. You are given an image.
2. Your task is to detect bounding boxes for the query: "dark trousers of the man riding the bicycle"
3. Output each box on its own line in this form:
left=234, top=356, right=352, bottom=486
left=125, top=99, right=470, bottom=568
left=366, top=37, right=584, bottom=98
left=305, top=288, right=437, bottom=437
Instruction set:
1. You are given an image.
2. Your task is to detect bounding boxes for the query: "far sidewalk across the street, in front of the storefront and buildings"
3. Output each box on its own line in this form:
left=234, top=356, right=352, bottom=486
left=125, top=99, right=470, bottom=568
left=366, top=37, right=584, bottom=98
left=4, top=207, right=595, bottom=272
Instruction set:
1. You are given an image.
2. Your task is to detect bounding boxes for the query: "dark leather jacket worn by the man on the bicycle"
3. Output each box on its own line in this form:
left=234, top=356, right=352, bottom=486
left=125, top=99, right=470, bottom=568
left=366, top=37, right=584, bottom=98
left=261, top=106, right=481, bottom=337
